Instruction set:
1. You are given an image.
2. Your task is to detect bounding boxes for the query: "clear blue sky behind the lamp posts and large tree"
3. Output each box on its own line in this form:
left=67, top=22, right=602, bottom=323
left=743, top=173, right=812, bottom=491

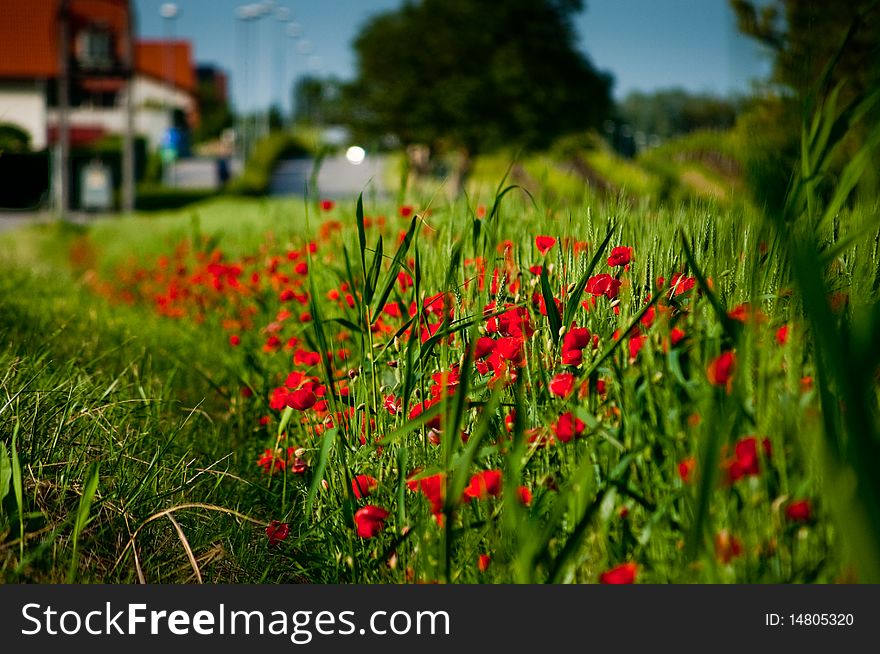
left=135, top=0, right=768, bottom=113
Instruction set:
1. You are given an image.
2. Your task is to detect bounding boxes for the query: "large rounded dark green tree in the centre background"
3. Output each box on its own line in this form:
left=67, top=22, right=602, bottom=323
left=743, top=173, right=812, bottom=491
left=348, top=0, right=611, bottom=190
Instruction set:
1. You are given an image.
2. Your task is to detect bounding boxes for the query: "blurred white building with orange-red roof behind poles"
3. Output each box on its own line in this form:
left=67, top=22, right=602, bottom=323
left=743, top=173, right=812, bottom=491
left=0, top=0, right=198, bottom=149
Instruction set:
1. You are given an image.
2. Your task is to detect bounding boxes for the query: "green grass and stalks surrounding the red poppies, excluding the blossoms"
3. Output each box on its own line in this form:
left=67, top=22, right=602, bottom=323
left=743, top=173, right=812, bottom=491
left=0, top=181, right=880, bottom=582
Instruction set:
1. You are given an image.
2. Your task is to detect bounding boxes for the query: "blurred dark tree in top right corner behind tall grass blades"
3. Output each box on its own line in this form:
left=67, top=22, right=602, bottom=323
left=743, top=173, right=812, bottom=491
left=730, top=0, right=880, bottom=204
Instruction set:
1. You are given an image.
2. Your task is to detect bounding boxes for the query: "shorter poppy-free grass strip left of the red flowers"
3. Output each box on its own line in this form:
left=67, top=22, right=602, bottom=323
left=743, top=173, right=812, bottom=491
left=0, top=240, right=324, bottom=583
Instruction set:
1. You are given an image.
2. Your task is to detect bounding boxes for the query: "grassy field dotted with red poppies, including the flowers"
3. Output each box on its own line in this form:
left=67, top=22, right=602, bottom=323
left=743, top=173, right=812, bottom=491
left=0, top=173, right=880, bottom=583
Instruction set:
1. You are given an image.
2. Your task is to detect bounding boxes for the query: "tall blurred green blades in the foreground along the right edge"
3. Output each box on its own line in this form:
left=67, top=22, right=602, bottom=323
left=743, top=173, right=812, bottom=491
left=769, top=37, right=880, bottom=583
